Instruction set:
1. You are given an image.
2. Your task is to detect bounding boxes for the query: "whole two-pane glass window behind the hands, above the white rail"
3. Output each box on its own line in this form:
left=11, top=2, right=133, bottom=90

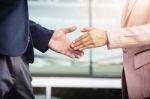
left=29, top=0, right=123, bottom=77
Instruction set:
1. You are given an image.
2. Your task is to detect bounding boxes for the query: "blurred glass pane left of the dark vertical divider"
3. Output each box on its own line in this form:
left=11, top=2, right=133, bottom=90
left=29, top=1, right=89, bottom=76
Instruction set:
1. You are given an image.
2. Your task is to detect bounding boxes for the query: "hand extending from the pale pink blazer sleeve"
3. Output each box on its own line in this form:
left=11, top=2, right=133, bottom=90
left=71, top=28, right=108, bottom=51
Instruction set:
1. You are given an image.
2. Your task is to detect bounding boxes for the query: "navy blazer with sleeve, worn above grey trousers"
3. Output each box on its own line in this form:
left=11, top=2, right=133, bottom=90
left=0, top=0, right=54, bottom=62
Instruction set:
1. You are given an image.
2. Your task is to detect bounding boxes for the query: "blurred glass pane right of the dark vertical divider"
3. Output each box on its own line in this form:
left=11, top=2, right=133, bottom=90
left=91, top=0, right=123, bottom=77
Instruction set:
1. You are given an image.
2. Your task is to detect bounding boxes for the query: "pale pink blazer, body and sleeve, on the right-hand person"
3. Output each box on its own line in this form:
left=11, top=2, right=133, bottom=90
left=107, top=0, right=150, bottom=99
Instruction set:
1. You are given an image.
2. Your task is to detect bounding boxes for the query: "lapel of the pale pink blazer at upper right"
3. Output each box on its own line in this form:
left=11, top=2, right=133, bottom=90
left=122, top=0, right=138, bottom=26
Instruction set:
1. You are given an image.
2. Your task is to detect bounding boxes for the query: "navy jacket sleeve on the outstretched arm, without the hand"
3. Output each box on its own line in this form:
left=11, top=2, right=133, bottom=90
left=29, top=21, right=54, bottom=52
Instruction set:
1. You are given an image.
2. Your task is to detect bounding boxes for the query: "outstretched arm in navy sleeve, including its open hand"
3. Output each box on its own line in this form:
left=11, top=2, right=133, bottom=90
left=30, top=21, right=83, bottom=58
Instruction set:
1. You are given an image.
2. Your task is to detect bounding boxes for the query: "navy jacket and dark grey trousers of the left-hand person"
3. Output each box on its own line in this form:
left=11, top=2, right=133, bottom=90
left=0, top=0, right=54, bottom=99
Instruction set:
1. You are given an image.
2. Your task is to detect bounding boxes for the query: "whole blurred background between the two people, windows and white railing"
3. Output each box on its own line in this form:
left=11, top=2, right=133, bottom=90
left=28, top=0, right=125, bottom=99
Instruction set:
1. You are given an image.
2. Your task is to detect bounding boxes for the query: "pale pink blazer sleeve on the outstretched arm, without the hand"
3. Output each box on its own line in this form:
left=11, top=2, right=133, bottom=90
left=107, top=23, right=150, bottom=49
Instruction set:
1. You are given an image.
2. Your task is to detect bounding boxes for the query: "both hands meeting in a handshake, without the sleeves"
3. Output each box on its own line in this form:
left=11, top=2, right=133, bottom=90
left=48, top=26, right=108, bottom=58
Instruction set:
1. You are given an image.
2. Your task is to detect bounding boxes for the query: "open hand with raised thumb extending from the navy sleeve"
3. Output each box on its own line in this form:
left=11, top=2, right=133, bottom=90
left=48, top=26, right=83, bottom=58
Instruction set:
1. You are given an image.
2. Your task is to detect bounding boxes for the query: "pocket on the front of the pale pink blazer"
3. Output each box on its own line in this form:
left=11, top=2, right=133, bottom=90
left=134, top=49, right=150, bottom=69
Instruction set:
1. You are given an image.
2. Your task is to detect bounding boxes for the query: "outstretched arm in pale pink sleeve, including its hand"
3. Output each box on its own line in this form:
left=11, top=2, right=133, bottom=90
left=72, top=23, right=150, bottom=50
